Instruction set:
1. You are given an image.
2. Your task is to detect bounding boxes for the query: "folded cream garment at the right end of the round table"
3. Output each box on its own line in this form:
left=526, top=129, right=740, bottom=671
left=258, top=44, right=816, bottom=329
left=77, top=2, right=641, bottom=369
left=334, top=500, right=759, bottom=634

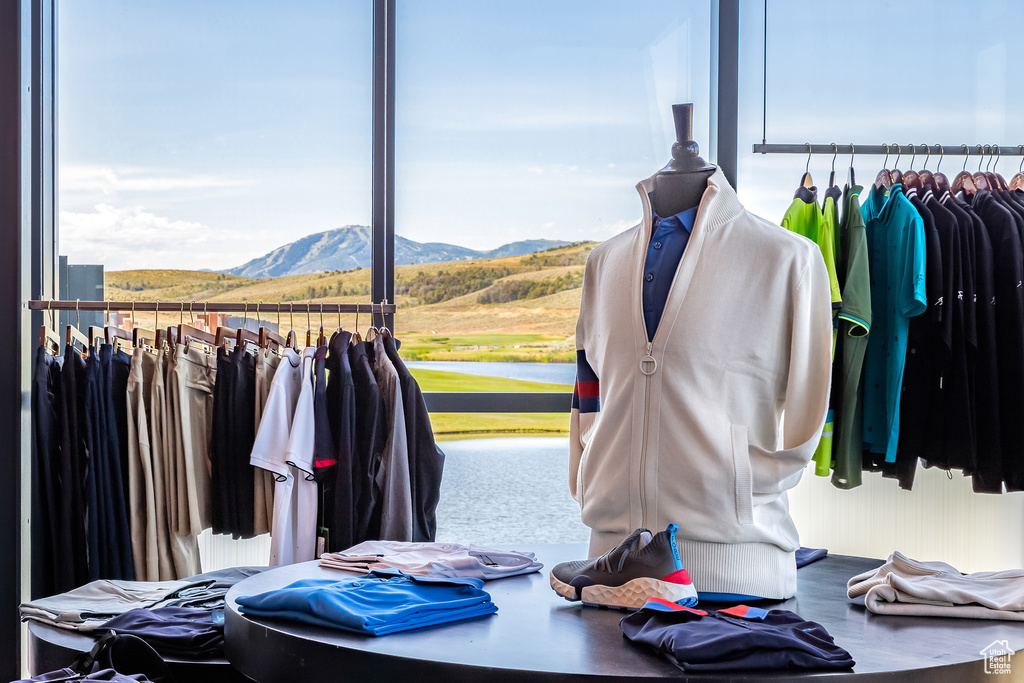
left=847, top=552, right=1024, bottom=622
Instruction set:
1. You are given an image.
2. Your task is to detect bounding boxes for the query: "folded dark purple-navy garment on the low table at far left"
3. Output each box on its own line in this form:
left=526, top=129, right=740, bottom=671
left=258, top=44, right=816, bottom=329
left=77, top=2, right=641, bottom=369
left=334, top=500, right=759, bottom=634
left=95, top=607, right=224, bottom=659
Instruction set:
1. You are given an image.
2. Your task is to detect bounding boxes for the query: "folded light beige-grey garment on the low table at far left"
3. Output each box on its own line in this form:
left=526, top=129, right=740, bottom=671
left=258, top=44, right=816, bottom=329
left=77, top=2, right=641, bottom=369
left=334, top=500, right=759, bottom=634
left=20, top=580, right=190, bottom=631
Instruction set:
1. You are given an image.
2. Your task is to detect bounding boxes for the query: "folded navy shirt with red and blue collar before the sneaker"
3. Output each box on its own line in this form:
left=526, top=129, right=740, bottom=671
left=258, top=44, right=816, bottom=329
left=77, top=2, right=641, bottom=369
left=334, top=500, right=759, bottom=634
left=618, top=598, right=854, bottom=672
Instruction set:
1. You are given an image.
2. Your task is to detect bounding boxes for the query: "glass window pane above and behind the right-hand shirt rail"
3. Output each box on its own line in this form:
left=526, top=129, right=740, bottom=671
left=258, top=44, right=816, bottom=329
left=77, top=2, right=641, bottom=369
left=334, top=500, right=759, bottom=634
left=737, top=0, right=1024, bottom=221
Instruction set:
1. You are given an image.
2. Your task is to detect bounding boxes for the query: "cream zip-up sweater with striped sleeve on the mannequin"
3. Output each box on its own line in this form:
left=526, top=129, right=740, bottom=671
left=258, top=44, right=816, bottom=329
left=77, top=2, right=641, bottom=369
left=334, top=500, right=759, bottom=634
left=569, top=170, right=831, bottom=598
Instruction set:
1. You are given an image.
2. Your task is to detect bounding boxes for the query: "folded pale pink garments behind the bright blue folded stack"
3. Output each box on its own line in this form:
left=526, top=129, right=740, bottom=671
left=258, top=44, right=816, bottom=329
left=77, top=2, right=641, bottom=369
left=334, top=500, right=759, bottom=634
left=319, top=541, right=544, bottom=581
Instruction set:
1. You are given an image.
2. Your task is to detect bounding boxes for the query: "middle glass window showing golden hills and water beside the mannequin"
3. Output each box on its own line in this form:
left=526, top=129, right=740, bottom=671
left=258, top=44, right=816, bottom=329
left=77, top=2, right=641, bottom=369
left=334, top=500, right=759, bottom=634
left=395, top=0, right=711, bottom=542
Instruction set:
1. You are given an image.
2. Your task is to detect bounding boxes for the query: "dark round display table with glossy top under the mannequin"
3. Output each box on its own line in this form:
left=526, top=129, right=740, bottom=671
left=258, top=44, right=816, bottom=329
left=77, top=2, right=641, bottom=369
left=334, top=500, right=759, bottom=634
left=224, top=545, right=1024, bottom=683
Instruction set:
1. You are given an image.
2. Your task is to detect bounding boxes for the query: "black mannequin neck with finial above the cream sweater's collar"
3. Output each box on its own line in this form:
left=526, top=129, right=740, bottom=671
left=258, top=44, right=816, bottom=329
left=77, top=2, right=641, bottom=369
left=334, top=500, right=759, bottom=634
left=650, top=103, right=717, bottom=217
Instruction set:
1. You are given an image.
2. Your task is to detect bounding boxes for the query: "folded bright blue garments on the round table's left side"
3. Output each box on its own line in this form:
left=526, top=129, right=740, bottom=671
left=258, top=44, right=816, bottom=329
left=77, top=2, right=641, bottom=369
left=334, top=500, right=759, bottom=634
left=238, top=569, right=498, bottom=636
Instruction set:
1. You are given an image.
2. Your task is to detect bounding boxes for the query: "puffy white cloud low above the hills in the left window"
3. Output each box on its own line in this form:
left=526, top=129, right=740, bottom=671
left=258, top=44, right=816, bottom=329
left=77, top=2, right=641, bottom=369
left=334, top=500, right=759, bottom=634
left=59, top=204, right=241, bottom=270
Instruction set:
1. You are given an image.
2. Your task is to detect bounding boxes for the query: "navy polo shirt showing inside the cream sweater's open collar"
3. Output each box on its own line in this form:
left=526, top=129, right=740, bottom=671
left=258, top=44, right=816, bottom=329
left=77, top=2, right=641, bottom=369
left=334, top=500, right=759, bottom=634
left=643, top=202, right=697, bottom=341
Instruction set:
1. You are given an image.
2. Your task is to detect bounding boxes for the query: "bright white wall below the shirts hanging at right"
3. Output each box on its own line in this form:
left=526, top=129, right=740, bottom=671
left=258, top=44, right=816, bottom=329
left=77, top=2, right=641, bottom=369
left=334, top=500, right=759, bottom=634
left=790, top=468, right=1024, bottom=572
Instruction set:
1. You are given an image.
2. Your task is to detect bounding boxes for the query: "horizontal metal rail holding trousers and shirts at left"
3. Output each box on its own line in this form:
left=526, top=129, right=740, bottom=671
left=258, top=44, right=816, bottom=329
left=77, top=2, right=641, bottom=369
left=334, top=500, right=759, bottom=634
left=29, top=299, right=397, bottom=314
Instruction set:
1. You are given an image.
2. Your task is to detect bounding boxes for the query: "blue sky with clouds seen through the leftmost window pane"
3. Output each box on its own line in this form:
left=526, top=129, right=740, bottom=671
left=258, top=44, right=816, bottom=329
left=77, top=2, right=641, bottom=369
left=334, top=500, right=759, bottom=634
left=58, top=0, right=372, bottom=274
